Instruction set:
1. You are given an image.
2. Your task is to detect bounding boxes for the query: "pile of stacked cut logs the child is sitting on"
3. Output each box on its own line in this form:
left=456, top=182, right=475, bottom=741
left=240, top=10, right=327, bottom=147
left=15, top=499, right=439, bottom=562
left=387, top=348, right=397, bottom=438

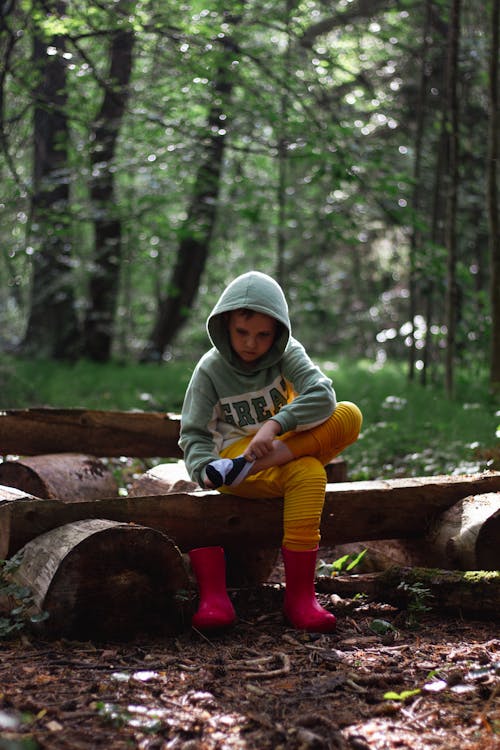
left=0, top=409, right=500, bottom=637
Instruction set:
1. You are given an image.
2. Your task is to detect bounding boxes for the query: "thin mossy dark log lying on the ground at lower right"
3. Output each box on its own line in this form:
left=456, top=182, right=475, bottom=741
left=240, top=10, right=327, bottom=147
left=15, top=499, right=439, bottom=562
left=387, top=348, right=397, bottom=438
left=316, top=566, right=500, bottom=621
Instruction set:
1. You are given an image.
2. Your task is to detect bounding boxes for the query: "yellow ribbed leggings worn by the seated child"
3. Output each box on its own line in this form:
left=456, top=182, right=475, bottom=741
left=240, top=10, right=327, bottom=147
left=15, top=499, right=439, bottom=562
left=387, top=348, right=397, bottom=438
left=220, top=401, right=363, bottom=550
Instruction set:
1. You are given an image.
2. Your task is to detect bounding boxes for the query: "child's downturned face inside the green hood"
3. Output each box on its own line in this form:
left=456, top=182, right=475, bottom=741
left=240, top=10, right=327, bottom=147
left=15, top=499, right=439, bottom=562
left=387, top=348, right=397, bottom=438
left=229, top=312, right=276, bottom=364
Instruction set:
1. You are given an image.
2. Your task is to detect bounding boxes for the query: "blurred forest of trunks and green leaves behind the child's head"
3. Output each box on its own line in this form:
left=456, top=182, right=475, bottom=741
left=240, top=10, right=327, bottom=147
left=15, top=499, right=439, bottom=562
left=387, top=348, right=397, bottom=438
left=0, top=0, right=500, bottom=395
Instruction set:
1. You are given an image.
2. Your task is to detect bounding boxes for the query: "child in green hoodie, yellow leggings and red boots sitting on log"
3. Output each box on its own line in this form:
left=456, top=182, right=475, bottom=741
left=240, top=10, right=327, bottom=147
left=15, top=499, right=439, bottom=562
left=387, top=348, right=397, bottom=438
left=179, top=271, right=362, bottom=633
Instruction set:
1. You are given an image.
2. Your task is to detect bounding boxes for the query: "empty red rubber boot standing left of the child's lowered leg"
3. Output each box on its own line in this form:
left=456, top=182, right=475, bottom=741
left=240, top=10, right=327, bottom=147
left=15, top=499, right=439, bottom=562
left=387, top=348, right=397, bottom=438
left=189, top=547, right=236, bottom=630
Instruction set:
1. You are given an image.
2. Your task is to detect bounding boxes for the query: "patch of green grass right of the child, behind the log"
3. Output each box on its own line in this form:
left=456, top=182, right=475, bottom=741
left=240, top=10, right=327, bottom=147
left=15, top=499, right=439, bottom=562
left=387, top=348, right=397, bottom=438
left=323, top=361, right=500, bottom=479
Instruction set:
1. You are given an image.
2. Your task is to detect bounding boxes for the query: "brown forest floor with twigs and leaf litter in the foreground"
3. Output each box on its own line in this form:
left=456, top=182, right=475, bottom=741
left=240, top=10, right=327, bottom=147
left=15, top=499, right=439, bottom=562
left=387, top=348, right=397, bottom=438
left=0, top=551, right=500, bottom=750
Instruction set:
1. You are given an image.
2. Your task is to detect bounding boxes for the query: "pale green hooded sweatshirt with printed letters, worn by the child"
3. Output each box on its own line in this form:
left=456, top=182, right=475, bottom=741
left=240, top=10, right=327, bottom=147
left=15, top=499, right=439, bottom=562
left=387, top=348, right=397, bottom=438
left=179, top=271, right=336, bottom=484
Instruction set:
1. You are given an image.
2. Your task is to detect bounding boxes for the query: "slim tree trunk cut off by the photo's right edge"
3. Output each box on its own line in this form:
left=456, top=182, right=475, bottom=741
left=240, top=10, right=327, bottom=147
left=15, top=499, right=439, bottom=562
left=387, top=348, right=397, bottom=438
left=487, top=0, right=500, bottom=394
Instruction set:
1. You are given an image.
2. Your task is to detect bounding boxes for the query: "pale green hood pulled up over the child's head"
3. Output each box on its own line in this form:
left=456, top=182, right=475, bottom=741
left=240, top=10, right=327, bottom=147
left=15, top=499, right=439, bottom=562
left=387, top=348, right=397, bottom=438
left=207, top=271, right=291, bottom=370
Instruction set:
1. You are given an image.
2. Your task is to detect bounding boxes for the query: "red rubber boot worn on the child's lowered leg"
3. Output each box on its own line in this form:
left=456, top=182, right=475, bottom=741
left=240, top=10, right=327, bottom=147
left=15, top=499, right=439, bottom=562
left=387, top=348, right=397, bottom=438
left=281, top=547, right=337, bottom=633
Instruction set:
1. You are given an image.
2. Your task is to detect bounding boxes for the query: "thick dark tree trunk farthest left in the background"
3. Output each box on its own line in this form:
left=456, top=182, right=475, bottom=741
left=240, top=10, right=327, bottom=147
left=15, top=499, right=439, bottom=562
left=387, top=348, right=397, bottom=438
left=22, top=0, right=79, bottom=359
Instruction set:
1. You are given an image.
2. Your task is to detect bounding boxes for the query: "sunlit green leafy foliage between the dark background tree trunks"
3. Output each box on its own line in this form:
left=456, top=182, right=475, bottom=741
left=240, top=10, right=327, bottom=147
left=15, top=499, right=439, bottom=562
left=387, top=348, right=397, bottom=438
left=0, top=0, right=490, bottom=374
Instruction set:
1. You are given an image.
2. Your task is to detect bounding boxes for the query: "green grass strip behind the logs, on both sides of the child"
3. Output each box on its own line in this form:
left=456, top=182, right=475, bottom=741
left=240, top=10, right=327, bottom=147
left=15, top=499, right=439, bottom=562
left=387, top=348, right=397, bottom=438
left=0, top=358, right=500, bottom=480
